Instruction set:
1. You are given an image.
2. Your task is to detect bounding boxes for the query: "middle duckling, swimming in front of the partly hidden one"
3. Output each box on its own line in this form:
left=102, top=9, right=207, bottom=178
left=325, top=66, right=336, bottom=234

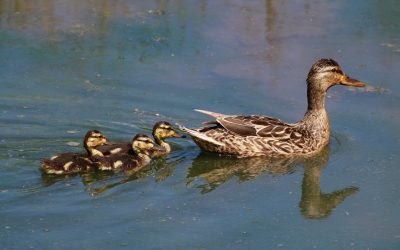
left=90, top=134, right=157, bottom=171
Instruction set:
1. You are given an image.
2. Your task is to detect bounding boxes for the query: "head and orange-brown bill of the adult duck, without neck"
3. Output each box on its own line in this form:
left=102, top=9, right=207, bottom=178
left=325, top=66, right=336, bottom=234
left=307, top=58, right=365, bottom=92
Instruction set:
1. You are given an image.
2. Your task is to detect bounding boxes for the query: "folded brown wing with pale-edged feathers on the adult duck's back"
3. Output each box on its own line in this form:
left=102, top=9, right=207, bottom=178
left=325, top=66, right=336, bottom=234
left=196, top=110, right=295, bottom=138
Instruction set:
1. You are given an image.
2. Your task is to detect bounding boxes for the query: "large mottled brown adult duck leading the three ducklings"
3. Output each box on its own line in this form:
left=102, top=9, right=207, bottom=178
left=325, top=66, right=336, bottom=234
left=182, top=59, right=365, bottom=157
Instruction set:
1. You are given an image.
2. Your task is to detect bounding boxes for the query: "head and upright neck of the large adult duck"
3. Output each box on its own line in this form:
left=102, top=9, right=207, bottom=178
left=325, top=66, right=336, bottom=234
left=307, top=58, right=365, bottom=109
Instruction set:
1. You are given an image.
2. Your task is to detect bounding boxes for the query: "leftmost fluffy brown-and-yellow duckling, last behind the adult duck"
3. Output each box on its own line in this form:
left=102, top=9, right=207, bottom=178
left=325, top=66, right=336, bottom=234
left=42, top=130, right=107, bottom=174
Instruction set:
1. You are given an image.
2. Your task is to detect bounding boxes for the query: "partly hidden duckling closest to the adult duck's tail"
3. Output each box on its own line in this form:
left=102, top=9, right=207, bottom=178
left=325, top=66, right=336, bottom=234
left=98, top=121, right=185, bottom=156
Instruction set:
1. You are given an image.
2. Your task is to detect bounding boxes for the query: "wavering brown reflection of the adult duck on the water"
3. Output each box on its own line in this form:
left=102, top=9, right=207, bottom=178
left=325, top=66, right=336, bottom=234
left=187, top=147, right=358, bottom=219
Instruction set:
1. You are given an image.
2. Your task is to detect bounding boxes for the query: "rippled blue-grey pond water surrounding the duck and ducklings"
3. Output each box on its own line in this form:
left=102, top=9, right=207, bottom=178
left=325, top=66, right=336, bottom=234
left=0, top=0, right=400, bottom=249
